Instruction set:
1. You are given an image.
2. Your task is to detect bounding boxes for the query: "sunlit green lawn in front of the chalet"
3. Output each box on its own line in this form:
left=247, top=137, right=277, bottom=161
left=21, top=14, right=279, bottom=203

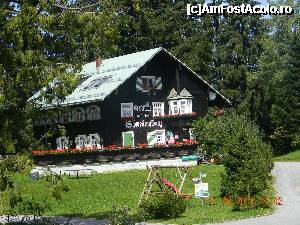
left=15, top=165, right=272, bottom=224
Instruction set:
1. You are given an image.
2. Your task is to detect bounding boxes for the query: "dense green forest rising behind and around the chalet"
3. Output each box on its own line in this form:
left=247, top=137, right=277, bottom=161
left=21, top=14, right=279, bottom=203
left=0, top=0, right=300, bottom=154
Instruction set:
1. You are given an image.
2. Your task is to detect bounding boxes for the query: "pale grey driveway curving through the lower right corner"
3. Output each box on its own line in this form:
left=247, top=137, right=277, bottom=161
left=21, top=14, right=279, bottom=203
left=203, top=162, right=300, bottom=225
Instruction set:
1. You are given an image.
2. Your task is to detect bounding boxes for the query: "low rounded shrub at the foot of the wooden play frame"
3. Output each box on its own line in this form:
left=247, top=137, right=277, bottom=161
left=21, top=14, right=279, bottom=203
left=141, top=190, right=186, bottom=218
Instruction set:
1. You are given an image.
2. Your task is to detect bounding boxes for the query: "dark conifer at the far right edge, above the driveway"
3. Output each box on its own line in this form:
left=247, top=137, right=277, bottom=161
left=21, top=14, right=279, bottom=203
left=270, top=32, right=300, bottom=151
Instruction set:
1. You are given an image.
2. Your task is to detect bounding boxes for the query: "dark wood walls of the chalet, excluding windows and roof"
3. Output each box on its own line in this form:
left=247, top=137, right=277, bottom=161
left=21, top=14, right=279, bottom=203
left=35, top=51, right=226, bottom=149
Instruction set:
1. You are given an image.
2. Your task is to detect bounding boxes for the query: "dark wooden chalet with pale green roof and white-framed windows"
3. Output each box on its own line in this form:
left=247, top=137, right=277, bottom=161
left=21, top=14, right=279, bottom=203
left=33, top=48, right=230, bottom=149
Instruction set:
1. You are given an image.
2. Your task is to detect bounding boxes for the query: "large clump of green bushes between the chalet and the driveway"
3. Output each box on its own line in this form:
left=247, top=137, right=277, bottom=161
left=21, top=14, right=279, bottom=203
left=194, top=113, right=273, bottom=209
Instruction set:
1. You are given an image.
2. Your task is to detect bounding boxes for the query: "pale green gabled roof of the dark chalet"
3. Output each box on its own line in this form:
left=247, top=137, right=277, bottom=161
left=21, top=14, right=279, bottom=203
left=31, top=48, right=229, bottom=107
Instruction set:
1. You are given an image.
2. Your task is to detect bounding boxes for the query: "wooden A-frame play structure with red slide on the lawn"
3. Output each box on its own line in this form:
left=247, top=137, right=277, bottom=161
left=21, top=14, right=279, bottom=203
left=138, top=165, right=194, bottom=206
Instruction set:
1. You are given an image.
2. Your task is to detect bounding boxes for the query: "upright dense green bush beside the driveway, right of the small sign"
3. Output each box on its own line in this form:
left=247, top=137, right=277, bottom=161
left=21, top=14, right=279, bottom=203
left=221, top=131, right=272, bottom=209
